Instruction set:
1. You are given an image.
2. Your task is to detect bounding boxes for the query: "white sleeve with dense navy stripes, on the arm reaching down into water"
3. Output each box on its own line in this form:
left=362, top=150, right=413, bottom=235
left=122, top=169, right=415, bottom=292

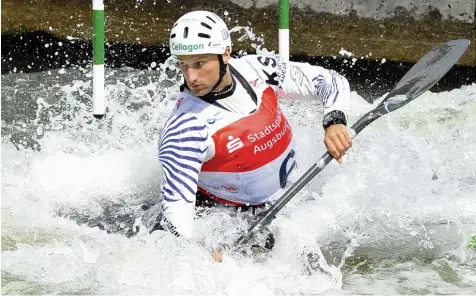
left=158, top=112, right=209, bottom=237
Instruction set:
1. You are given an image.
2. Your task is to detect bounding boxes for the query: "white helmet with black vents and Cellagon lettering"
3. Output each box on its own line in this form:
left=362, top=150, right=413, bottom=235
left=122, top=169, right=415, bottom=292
left=169, top=10, right=231, bottom=55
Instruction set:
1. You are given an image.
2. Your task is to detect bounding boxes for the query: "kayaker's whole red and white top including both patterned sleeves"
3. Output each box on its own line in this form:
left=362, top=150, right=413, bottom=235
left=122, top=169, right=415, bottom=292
left=158, top=55, right=350, bottom=236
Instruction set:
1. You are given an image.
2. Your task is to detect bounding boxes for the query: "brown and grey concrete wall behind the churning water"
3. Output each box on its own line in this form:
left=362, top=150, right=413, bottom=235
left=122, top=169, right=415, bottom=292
left=1, top=0, right=476, bottom=71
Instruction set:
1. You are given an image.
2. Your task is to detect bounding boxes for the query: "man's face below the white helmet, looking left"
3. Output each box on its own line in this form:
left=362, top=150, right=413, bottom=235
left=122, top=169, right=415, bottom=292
left=177, top=54, right=220, bottom=96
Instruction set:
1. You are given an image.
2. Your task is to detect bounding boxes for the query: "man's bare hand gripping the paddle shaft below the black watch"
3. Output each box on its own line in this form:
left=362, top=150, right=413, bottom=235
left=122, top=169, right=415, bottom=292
left=324, top=124, right=352, bottom=163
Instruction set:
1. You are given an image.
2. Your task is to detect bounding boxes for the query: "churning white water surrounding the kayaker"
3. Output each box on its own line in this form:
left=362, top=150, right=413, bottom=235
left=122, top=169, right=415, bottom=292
left=1, top=45, right=476, bottom=295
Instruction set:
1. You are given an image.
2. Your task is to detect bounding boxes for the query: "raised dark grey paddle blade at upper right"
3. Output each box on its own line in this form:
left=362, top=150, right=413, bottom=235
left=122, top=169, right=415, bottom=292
left=376, top=39, right=469, bottom=115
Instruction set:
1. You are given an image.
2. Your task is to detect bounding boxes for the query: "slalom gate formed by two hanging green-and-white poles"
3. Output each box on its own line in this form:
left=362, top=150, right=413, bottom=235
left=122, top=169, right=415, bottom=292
left=92, top=0, right=289, bottom=119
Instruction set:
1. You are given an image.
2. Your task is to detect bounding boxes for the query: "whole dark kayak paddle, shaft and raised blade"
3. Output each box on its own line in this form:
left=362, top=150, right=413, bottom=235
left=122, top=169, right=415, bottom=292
left=233, top=39, right=469, bottom=248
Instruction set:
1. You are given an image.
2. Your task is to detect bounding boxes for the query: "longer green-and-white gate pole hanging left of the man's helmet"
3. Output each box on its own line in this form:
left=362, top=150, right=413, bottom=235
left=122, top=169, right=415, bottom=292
left=93, top=0, right=105, bottom=118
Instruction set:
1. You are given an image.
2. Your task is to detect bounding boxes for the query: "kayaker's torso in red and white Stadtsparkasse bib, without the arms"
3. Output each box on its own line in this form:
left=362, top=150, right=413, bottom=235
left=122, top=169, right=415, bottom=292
left=171, top=58, right=295, bottom=205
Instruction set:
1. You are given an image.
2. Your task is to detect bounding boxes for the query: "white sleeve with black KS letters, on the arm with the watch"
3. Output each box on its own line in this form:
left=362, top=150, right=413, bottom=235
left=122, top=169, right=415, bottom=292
left=243, top=55, right=351, bottom=117
